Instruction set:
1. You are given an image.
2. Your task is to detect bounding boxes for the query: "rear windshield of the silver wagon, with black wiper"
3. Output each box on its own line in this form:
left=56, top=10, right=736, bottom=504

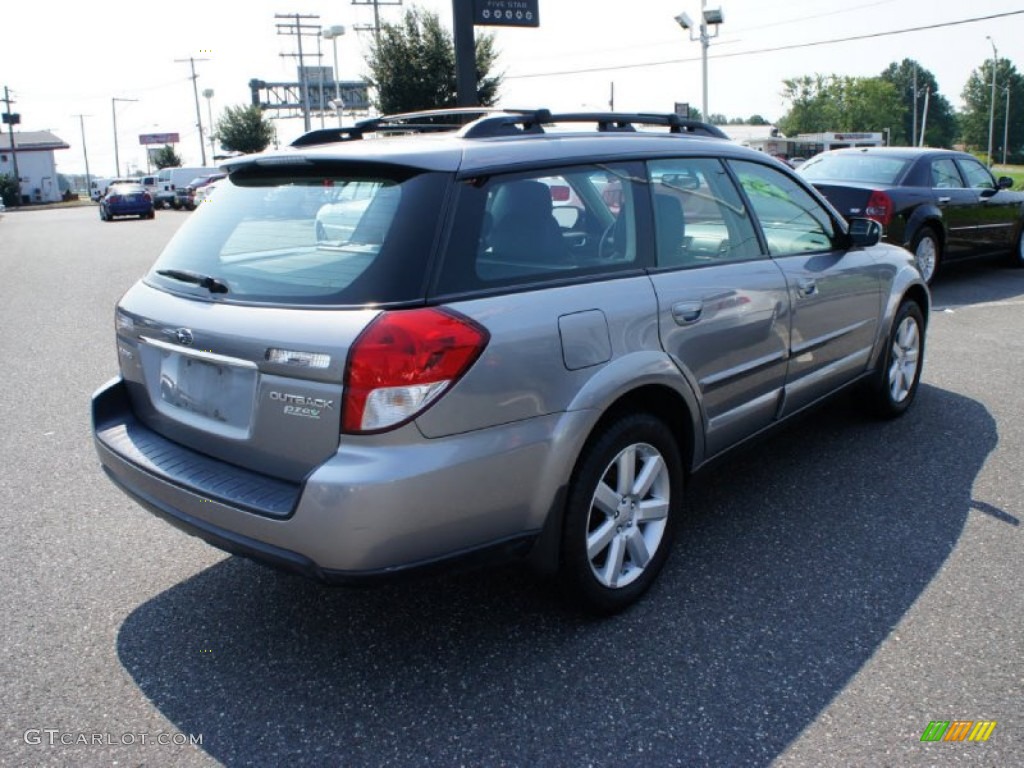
left=146, top=168, right=449, bottom=305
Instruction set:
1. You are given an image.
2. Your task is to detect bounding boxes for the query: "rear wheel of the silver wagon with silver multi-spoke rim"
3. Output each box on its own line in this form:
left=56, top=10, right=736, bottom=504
left=561, top=413, right=683, bottom=615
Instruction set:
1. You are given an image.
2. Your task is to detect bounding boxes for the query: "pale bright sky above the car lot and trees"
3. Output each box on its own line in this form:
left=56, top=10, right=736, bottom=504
left=0, top=0, right=1024, bottom=176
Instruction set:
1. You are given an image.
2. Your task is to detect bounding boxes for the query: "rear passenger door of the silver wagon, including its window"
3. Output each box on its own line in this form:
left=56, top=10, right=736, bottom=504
left=648, top=158, right=790, bottom=456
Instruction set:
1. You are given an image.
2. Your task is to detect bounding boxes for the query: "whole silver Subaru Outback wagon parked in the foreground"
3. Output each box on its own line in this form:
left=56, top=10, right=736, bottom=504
left=92, top=111, right=930, bottom=613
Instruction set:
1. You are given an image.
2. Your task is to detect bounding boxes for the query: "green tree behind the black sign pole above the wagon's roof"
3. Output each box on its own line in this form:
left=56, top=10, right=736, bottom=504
left=367, top=7, right=502, bottom=115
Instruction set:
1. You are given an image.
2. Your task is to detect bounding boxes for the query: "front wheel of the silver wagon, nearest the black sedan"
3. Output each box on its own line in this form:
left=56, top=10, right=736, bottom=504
left=868, top=299, right=925, bottom=419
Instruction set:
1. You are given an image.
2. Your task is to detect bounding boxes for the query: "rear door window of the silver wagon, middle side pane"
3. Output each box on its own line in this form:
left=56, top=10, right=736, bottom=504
left=648, top=158, right=761, bottom=268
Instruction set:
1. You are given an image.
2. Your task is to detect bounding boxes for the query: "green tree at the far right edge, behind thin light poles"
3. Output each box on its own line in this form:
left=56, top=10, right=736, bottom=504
left=959, top=58, right=1024, bottom=162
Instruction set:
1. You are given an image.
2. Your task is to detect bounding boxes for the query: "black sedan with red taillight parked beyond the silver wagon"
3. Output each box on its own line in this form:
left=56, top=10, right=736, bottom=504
left=800, top=146, right=1024, bottom=283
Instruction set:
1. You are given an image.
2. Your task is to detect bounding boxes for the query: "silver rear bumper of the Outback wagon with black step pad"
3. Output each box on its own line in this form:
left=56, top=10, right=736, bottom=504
left=93, top=379, right=589, bottom=582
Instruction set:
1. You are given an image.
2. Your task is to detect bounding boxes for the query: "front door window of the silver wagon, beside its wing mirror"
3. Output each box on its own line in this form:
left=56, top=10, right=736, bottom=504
left=730, top=161, right=837, bottom=256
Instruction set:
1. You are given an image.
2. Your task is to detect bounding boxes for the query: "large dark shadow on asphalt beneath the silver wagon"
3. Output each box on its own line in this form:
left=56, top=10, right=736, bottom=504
left=118, top=385, right=991, bottom=766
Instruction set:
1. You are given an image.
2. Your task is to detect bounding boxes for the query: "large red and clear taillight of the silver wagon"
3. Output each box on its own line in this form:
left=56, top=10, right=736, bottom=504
left=341, top=308, right=490, bottom=433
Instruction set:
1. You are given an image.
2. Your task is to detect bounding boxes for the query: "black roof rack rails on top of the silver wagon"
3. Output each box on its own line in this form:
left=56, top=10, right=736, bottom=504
left=291, top=106, right=728, bottom=146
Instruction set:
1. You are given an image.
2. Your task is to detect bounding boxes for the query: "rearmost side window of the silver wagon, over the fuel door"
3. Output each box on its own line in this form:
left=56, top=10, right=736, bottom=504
left=438, top=163, right=647, bottom=293
